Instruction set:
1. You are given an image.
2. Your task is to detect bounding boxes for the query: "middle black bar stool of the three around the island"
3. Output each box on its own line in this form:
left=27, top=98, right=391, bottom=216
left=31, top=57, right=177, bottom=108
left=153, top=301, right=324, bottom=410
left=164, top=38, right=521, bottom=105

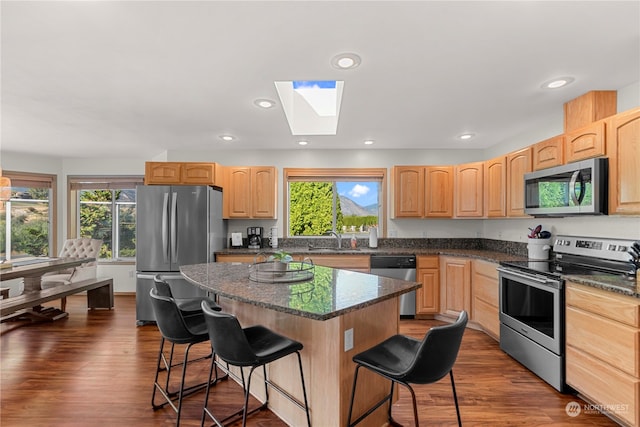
left=201, top=302, right=311, bottom=426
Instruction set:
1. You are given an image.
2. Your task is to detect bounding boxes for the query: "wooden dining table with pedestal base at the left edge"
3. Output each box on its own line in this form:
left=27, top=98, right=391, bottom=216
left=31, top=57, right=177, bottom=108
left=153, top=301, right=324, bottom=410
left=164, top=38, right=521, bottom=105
left=0, top=258, right=96, bottom=321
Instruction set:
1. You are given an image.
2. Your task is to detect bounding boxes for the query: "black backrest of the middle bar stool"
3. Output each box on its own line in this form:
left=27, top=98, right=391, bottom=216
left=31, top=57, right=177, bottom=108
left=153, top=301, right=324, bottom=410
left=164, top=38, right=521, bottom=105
left=202, top=301, right=260, bottom=366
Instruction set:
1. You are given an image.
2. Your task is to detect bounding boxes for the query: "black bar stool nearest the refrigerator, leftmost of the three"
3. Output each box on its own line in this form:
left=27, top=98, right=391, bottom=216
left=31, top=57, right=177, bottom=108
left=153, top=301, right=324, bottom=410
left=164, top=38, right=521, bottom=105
left=149, top=288, right=220, bottom=426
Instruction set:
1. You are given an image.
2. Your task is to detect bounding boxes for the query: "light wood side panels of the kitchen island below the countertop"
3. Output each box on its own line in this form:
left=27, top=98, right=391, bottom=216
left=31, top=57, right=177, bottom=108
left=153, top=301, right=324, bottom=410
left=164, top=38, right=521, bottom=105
left=220, top=298, right=399, bottom=426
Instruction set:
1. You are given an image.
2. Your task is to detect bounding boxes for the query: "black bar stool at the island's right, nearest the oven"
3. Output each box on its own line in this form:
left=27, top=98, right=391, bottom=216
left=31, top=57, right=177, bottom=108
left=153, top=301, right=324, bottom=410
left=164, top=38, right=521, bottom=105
left=347, top=311, right=468, bottom=427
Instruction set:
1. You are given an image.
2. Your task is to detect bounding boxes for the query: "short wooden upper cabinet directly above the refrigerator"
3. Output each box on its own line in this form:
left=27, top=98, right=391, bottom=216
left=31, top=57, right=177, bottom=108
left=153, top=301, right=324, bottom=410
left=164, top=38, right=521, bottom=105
left=144, top=162, right=222, bottom=186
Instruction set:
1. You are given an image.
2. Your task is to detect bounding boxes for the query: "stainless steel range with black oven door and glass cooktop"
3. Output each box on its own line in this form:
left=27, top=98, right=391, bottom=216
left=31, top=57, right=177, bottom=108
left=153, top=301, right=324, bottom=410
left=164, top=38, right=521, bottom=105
left=498, top=236, right=637, bottom=392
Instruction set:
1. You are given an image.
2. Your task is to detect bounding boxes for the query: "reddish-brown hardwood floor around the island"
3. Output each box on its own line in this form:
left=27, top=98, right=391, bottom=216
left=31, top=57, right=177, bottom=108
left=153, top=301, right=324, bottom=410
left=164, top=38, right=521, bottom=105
left=0, top=295, right=616, bottom=427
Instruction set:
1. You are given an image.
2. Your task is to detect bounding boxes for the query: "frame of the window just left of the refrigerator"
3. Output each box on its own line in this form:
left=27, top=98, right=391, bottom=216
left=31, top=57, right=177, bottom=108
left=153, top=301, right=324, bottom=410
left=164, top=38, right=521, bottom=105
left=67, top=175, right=144, bottom=264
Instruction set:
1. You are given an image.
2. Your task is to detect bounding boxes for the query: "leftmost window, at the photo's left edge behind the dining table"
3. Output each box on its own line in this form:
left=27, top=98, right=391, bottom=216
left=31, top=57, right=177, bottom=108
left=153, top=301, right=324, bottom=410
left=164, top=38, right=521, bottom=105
left=0, top=171, right=56, bottom=259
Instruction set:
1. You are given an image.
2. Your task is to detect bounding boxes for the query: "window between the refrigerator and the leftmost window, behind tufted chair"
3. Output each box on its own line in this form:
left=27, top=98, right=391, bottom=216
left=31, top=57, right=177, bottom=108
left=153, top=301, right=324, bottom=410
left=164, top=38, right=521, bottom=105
left=68, top=176, right=142, bottom=260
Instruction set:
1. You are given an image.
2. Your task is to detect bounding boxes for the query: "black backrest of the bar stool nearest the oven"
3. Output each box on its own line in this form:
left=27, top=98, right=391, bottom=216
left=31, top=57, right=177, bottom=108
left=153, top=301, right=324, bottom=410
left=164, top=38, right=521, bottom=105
left=403, top=311, right=468, bottom=384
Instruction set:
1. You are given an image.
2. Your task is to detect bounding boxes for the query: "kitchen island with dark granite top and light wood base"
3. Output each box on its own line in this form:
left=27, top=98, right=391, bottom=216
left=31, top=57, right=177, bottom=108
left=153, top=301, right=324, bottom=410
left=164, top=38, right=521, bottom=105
left=181, top=263, right=420, bottom=426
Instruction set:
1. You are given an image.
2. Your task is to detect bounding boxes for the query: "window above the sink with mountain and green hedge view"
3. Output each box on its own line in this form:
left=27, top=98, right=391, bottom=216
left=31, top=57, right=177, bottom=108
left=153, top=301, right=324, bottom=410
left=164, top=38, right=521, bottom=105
left=284, top=169, right=386, bottom=241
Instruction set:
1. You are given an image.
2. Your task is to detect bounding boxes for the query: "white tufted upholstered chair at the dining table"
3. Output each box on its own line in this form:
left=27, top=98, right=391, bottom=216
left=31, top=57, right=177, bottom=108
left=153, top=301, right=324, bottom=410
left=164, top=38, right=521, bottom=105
left=42, top=238, right=102, bottom=311
